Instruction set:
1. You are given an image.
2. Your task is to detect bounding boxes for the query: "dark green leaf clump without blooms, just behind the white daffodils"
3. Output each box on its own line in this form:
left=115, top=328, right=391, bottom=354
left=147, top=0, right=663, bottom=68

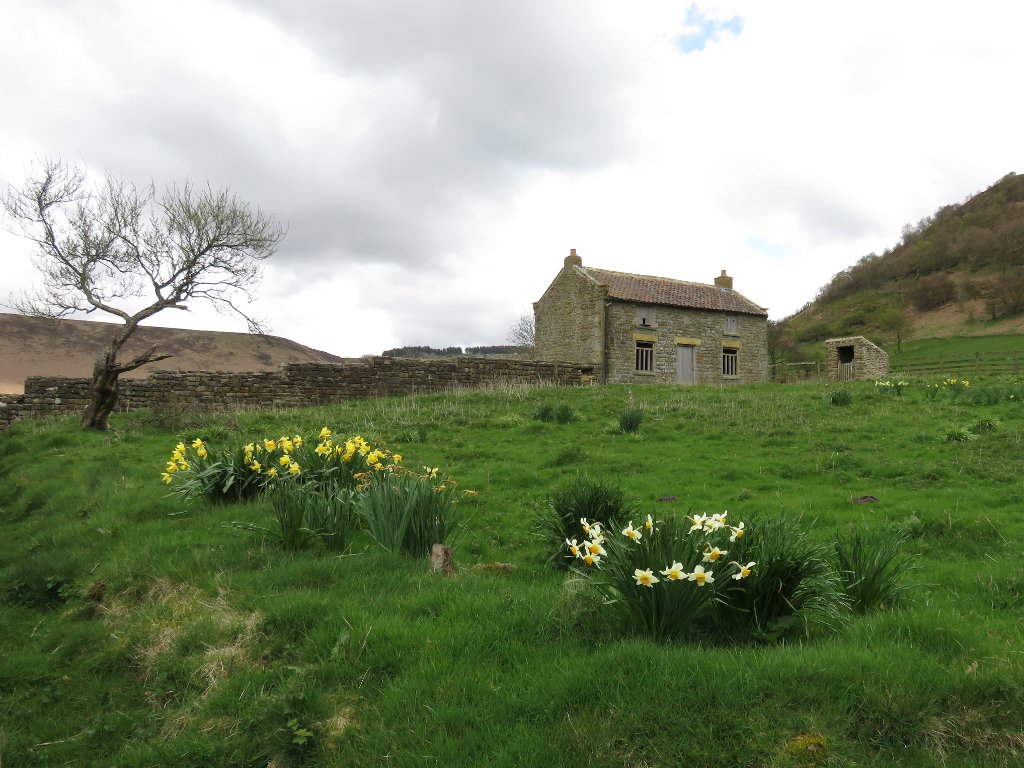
left=534, top=475, right=634, bottom=567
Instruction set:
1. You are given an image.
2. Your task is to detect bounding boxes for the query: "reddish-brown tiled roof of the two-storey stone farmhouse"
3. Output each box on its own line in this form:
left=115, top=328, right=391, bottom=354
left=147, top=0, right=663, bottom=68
left=579, top=266, right=768, bottom=317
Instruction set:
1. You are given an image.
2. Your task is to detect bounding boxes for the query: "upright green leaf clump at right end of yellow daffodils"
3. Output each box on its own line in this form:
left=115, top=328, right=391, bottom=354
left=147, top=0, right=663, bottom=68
left=359, top=468, right=458, bottom=557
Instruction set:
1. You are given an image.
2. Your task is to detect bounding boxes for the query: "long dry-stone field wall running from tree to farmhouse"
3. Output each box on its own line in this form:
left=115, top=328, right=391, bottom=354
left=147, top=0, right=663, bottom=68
left=0, top=357, right=594, bottom=429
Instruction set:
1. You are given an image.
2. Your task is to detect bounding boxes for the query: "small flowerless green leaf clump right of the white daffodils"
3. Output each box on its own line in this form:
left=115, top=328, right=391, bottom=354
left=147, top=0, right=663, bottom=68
left=834, top=534, right=913, bottom=613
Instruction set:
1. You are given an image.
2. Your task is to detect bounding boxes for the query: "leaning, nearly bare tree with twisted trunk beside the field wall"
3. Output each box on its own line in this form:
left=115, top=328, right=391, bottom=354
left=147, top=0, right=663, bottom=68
left=0, top=159, right=285, bottom=429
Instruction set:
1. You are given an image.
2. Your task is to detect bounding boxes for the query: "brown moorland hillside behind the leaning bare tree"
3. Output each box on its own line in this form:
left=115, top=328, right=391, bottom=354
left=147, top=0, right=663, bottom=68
left=0, top=313, right=342, bottom=394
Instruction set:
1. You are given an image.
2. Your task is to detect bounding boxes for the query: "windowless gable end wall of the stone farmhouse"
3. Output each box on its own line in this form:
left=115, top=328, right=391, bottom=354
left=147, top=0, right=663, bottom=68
left=534, top=249, right=608, bottom=366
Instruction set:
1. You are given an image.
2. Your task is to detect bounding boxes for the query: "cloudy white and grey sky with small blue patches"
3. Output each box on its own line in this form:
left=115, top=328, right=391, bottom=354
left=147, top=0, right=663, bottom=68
left=0, top=0, right=1024, bottom=356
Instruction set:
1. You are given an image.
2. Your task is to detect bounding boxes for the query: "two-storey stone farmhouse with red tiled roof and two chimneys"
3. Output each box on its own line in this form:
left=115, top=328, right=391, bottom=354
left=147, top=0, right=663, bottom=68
left=534, top=248, right=768, bottom=384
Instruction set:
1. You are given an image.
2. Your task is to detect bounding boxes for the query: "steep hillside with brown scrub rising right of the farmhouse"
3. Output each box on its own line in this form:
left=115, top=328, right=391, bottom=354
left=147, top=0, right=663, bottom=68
left=772, top=173, right=1024, bottom=359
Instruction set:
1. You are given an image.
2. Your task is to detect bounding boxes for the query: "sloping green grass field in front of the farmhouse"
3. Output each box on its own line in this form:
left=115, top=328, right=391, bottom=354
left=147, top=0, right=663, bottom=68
left=0, top=380, right=1024, bottom=768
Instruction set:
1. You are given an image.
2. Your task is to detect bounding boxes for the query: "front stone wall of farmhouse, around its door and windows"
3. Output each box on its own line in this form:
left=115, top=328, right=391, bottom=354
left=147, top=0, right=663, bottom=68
left=607, top=301, right=768, bottom=384
